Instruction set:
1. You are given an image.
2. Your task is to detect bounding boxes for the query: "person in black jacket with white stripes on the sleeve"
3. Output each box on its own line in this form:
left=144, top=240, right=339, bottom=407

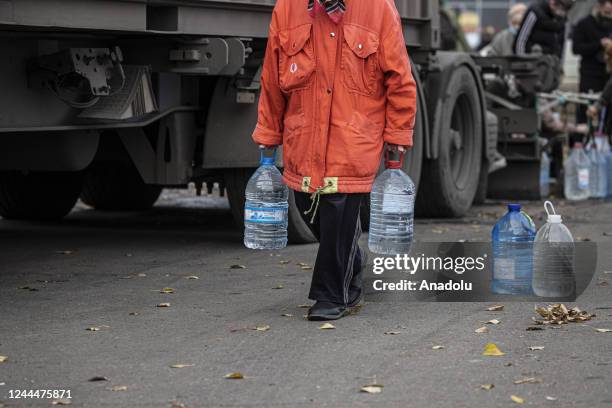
left=514, top=0, right=575, bottom=60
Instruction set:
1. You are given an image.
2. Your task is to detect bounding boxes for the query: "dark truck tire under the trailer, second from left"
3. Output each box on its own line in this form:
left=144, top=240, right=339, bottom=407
left=81, top=161, right=162, bottom=211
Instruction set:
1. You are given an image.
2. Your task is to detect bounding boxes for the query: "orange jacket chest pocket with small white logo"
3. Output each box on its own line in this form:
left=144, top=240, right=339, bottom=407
left=278, top=24, right=315, bottom=92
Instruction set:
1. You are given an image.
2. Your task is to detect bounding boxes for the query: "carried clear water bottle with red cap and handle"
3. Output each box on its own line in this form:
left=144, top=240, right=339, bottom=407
left=368, top=150, right=416, bottom=255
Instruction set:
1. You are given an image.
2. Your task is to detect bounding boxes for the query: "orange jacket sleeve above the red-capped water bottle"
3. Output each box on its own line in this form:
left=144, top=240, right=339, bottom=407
left=379, top=5, right=417, bottom=146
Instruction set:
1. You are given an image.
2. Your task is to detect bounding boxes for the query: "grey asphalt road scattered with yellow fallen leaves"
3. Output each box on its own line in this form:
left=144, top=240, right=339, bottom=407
left=0, top=193, right=612, bottom=407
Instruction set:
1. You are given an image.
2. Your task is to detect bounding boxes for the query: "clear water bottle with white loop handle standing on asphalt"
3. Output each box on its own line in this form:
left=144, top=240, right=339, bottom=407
left=533, top=201, right=576, bottom=297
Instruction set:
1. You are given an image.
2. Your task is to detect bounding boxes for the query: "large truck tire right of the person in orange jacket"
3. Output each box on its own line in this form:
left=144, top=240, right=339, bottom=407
left=417, top=65, right=483, bottom=217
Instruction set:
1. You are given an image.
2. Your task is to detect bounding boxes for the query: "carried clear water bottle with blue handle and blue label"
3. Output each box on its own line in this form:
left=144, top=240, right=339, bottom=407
left=244, top=149, right=289, bottom=249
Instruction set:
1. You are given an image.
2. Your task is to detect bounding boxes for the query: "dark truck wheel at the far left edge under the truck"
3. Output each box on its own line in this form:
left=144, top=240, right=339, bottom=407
left=0, top=171, right=83, bottom=220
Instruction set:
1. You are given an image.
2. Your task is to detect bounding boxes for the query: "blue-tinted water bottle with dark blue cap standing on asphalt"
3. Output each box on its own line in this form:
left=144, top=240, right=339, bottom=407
left=491, top=204, right=536, bottom=295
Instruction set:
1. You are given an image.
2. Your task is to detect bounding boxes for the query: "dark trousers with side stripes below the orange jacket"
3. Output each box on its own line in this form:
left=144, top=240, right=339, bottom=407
left=295, top=191, right=365, bottom=305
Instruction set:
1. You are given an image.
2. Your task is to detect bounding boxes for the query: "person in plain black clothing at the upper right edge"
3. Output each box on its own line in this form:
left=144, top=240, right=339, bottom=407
left=572, top=0, right=612, bottom=123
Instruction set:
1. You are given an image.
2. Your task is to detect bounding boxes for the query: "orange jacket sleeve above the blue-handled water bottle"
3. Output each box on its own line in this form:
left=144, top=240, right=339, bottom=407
left=252, top=11, right=286, bottom=146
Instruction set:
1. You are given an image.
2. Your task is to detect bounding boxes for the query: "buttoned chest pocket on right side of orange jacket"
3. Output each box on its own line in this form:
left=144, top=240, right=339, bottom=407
left=342, top=24, right=379, bottom=95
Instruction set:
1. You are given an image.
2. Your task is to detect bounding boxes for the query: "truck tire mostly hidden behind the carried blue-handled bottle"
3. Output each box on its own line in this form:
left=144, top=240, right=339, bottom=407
left=224, top=169, right=317, bottom=244
